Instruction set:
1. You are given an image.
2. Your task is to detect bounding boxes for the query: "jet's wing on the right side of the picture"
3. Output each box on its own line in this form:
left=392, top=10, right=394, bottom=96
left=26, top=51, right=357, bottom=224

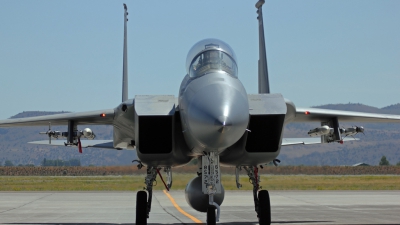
left=293, top=108, right=400, bottom=123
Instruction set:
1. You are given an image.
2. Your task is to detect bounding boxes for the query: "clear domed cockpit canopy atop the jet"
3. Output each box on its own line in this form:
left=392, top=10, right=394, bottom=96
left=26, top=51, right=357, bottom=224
left=186, top=39, right=238, bottom=77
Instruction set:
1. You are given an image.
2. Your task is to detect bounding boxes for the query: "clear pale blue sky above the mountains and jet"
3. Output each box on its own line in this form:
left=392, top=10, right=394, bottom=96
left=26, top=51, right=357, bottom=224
left=0, top=0, right=400, bottom=119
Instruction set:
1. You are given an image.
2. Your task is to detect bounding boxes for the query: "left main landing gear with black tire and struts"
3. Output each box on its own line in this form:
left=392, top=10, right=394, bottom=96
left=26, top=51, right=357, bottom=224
left=136, top=162, right=172, bottom=225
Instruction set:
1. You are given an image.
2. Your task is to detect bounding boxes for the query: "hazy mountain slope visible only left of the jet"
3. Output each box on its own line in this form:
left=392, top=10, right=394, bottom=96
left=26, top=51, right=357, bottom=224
left=0, top=111, right=136, bottom=166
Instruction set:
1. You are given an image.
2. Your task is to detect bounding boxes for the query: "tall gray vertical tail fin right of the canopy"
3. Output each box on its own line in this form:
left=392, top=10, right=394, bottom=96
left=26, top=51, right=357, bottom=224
left=256, top=0, right=270, bottom=94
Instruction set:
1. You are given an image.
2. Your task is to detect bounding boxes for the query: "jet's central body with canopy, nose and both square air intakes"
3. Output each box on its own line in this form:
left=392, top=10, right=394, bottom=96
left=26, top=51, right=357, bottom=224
left=114, top=39, right=288, bottom=167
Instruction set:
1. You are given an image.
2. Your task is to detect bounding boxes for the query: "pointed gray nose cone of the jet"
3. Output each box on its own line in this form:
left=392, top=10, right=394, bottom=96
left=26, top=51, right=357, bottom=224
left=187, top=84, right=249, bottom=151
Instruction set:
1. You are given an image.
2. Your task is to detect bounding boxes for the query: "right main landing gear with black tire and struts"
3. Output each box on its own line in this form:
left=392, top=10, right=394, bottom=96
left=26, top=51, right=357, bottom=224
left=236, top=166, right=271, bottom=225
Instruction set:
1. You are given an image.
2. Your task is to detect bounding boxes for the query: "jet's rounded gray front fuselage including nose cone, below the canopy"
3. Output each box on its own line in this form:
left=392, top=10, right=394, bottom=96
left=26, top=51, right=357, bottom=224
left=179, top=72, right=249, bottom=154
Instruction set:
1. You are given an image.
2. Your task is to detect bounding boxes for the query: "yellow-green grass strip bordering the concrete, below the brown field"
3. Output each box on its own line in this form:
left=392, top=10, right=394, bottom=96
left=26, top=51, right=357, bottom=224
left=0, top=173, right=400, bottom=191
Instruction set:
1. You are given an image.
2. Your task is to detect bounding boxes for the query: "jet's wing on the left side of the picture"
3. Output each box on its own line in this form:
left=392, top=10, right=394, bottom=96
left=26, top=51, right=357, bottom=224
left=0, top=109, right=114, bottom=127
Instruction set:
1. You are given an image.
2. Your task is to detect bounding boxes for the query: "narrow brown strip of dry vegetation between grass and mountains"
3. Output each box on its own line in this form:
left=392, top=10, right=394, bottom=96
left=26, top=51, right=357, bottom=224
left=0, top=165, right=400, bottom=176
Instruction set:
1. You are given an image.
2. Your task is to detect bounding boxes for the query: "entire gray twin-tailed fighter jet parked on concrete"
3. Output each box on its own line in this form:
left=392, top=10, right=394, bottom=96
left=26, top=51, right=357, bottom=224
left=0, top=0, right=400, bottom=225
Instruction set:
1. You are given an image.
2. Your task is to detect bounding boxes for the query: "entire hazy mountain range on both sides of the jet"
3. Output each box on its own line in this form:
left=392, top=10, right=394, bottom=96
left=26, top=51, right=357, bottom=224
left=0, top=103, right=400, bottom=166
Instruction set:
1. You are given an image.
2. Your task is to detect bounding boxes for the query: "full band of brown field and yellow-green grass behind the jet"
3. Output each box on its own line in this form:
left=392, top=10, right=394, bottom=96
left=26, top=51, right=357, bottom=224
left=0, top=165, right=400, bottom=191
